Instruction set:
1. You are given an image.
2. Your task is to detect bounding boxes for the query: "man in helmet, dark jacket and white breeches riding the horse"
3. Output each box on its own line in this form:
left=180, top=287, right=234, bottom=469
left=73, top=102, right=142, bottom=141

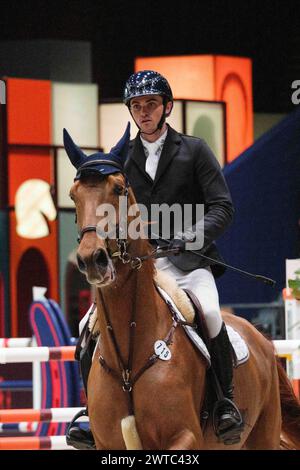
left=68, top=70, right=242, bottom=447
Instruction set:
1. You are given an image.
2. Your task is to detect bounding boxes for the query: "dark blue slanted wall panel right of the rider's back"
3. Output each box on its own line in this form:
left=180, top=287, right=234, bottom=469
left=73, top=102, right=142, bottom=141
left=218, top=109, right=300, bottom=310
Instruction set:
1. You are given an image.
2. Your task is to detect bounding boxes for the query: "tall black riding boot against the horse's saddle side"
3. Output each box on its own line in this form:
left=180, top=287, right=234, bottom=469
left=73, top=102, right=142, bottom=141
left=211, top=323, right=243, bottom=444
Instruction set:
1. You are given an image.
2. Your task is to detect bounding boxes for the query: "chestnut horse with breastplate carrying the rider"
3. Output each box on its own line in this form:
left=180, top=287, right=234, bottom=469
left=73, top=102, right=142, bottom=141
left=70, top=173, right=300, bottom=450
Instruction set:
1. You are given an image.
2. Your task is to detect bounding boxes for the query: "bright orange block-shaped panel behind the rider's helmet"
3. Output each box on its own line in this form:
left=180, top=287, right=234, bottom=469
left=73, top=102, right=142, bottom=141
left=135, top=55, right=253, bottom=162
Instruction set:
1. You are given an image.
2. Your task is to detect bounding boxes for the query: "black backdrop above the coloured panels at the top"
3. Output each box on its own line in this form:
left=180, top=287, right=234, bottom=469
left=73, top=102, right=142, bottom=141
left=0, top=0, right=300, bottom=112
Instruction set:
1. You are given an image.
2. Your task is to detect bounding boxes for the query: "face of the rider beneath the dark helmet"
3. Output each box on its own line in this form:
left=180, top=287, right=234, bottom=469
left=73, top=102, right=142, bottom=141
left=130, top=95, right=172, bottom=134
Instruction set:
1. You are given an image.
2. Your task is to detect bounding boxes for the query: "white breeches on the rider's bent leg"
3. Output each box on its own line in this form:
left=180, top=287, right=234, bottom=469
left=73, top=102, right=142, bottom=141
left=155, top=258, right=223, bottom=338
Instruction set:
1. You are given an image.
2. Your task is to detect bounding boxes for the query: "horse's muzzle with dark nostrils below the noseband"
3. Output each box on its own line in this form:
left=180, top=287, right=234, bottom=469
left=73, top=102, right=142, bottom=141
left=77, top=248, right=115, bottom=285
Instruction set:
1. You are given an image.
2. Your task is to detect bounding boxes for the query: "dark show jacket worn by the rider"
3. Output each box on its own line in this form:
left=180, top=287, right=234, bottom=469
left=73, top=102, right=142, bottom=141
left=125, top=126, right=234, bottom=277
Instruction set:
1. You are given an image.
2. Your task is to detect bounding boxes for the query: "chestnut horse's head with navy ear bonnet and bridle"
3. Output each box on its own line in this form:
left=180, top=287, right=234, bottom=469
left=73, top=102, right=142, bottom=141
left=64, top=123, right=135, bottom=287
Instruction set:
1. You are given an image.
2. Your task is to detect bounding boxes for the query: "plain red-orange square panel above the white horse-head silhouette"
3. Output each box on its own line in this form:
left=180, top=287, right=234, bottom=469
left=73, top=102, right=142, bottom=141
left=7, top=78, right=51, bottom=145
